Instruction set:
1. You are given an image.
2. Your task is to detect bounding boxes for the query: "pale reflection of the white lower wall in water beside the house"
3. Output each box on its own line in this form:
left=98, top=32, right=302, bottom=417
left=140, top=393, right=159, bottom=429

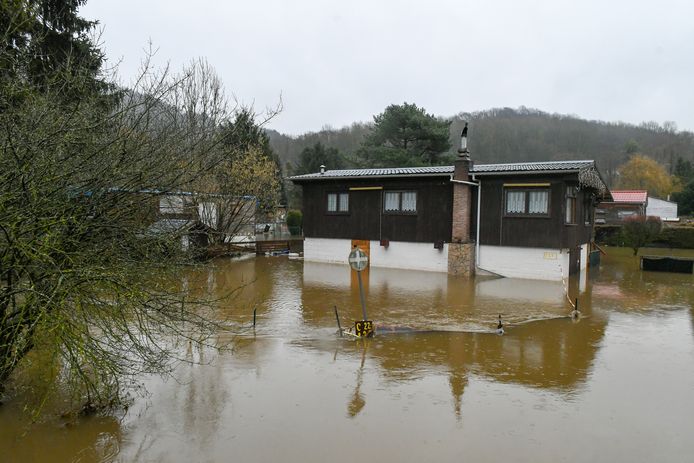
left=301, top=262, right=588, bottom=331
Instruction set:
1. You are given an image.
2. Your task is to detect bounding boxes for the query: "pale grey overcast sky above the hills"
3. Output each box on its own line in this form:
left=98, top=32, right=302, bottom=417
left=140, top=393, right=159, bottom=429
left=81, top=0, right=694, bottom=134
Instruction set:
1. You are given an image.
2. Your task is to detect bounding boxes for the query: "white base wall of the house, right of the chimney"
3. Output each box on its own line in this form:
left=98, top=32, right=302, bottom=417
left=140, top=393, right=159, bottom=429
left=479, top=246, right=569, bottom=281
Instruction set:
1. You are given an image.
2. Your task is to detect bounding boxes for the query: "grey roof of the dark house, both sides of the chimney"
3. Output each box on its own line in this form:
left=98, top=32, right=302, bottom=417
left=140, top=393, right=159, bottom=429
left=289, top=160, right=595, bottom=181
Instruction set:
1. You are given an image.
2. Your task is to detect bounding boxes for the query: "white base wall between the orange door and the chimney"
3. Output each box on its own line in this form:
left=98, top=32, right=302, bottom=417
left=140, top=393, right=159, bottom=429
left=371, top=241, right=448, bottom=272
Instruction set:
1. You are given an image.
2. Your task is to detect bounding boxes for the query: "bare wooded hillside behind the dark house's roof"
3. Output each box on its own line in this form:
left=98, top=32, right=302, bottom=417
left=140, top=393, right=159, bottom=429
left=268, top=107, right=694, bottom=187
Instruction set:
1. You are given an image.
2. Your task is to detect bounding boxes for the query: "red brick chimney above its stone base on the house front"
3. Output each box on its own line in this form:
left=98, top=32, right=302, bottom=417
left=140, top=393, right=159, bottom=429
left=452, top=122, right=472, bottom=243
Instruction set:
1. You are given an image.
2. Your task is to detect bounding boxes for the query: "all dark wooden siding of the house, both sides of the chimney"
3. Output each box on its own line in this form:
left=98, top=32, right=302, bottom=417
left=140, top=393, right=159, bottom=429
left=302, top=174, right=592, bottom=249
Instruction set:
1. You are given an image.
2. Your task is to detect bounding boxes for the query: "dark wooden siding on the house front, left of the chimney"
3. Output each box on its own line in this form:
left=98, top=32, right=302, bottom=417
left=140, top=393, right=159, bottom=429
left=302, top=177, right=453, bottom=243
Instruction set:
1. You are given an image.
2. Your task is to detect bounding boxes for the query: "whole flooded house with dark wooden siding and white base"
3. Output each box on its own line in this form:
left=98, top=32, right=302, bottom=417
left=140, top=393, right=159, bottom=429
left=290, top=153, right=609, bottom=280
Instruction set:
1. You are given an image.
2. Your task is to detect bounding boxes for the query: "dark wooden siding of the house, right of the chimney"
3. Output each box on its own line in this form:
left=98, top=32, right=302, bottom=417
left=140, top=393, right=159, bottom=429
left=479, top=174, right=592, bottom=249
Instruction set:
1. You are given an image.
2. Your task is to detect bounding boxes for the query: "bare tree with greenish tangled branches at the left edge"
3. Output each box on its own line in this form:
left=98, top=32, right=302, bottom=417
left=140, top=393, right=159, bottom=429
left=0, top=40, right=260, bottom=411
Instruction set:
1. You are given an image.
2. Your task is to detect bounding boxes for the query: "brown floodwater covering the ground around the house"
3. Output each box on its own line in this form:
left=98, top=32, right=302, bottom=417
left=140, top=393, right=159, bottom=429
left=0, top=249, right=694, bottom=462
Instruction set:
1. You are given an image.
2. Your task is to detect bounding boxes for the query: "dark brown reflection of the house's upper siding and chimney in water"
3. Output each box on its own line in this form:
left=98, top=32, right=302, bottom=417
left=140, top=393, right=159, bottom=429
left=324, top=316, right=607, bottom=417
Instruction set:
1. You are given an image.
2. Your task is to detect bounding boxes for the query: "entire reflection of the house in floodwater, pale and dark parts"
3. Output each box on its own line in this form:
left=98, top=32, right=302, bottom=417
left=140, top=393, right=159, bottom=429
left=302, top=262, right=607, bottom=417
